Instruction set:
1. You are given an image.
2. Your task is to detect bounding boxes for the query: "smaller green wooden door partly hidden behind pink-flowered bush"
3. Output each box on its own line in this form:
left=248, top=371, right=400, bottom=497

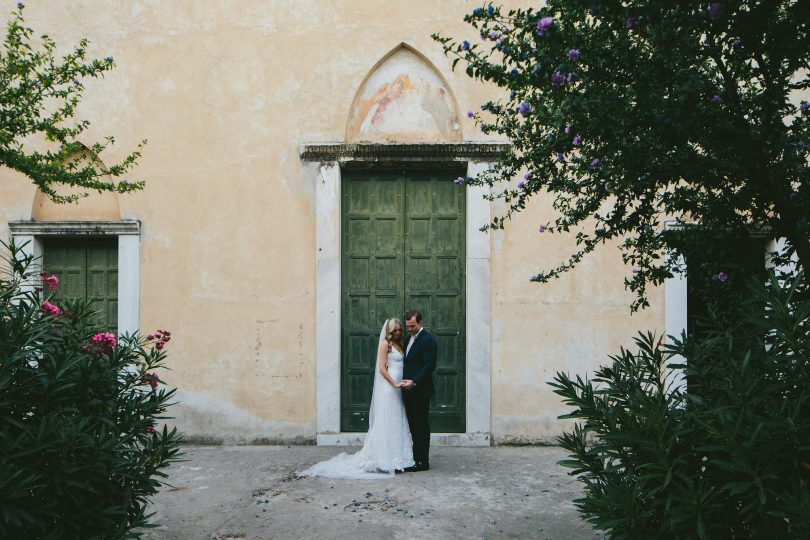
left=43, top=238, right=118, bottom=332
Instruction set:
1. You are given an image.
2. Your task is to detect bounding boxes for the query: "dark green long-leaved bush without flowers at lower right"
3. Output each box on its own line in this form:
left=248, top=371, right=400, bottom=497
left=550, top=274, right=810, bottom=539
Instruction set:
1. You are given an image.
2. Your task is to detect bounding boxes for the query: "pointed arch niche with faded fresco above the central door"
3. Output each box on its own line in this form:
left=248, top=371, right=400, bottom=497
left=346, top=43, right=462, bottom=143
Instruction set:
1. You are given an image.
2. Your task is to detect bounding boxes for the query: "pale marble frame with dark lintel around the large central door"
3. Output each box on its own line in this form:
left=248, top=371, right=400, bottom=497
left=300, top=143, right=506, bottom=446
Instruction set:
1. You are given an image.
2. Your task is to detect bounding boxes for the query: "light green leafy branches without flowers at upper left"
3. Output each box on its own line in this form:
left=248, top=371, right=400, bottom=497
left=0, top=2, right=146, bottom=202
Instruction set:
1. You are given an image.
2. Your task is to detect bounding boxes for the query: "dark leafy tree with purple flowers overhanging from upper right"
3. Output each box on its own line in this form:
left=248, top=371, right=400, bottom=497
left=434, top=0, right=810, bottom=309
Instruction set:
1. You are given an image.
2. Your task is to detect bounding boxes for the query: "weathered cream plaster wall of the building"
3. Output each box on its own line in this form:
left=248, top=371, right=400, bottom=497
left=0, top=0, right=663, bottom=442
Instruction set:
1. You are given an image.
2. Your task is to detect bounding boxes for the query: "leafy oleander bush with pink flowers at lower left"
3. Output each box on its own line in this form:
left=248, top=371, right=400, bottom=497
left=0, top=244, right=180, bottom=538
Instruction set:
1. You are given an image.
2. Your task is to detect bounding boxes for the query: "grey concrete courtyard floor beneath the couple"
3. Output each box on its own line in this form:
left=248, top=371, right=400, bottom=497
left=139, top=446, right=602, bottom=540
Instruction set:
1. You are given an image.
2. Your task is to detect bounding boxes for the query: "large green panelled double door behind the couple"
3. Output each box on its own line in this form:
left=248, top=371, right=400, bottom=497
left=341, top=171, right=465, bottom=432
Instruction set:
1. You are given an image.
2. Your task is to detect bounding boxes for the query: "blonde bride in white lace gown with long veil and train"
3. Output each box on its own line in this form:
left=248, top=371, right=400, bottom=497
left=300, top=319, right=414, bottom=479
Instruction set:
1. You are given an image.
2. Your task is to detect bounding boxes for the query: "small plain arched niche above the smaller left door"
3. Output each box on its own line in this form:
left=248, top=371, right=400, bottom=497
left=31, top=146, right=121, bottom=221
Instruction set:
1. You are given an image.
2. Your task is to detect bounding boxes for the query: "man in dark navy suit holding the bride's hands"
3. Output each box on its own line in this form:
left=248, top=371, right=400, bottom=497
left=402, top=311, right=437, bottom=472
